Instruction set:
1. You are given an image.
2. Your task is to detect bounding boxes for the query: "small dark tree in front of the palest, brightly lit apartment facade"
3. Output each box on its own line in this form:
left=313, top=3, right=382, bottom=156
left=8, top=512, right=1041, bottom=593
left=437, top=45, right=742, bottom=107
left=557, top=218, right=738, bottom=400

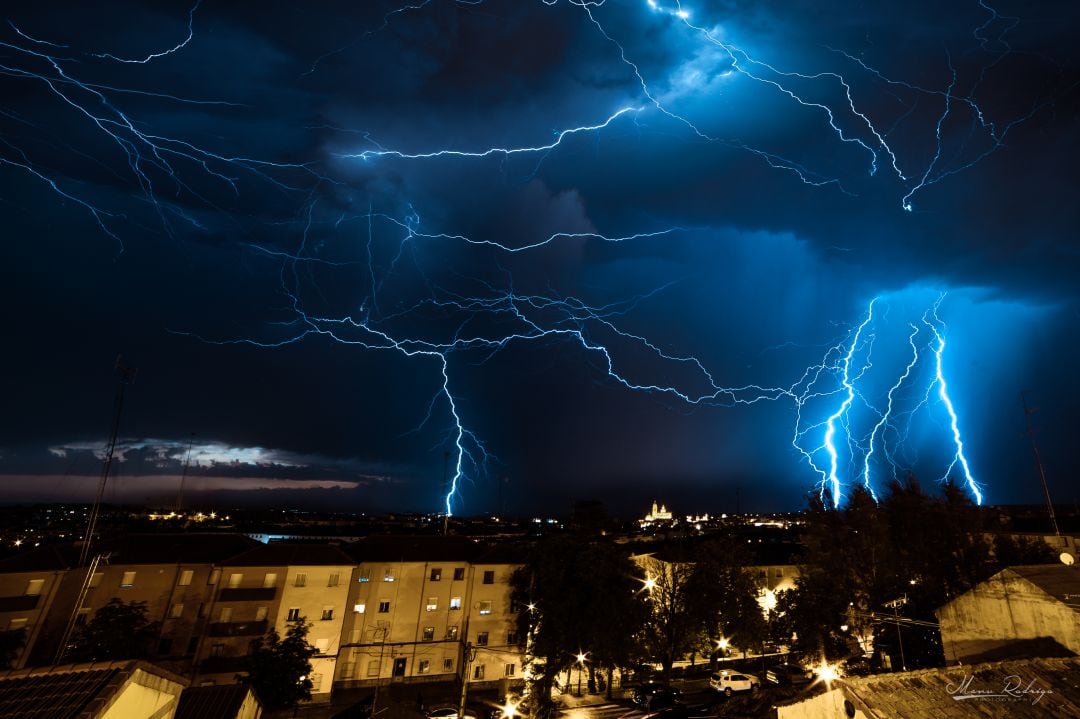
left=246, top=620, right=319, bottom=710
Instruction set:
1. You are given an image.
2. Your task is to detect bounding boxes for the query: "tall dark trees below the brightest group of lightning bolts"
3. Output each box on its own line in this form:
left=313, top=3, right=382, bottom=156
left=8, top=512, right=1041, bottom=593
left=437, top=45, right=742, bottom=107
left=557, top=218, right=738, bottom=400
left=769, top=476, right=1055, bottom=668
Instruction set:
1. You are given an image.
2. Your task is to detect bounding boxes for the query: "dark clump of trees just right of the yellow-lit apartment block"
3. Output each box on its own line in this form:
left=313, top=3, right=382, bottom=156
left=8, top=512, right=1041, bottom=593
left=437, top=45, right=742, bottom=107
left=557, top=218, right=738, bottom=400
left=511, top=535, right=765, bottom=711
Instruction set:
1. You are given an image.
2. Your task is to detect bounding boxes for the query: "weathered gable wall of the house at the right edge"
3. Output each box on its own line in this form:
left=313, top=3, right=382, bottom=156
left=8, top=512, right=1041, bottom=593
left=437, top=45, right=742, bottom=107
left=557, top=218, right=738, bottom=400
left=937, top=570, right=1080, bottom=663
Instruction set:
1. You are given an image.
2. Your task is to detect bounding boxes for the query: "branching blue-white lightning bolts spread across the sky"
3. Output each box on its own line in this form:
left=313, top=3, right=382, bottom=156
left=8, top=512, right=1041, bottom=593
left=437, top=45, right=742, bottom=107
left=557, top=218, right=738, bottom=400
left=6, top=0, right=1045, bottom=515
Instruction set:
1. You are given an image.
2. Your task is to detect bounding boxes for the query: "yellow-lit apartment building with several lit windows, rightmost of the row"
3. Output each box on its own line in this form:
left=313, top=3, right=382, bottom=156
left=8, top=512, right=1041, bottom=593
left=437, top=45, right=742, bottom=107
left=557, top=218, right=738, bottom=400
left=335, top=537, right=524, bottom=687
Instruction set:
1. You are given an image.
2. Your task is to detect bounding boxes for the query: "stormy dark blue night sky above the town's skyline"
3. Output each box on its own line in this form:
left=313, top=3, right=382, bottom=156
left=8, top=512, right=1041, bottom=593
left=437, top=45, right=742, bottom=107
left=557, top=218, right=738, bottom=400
left=0, top=0, right=1080, bottom=515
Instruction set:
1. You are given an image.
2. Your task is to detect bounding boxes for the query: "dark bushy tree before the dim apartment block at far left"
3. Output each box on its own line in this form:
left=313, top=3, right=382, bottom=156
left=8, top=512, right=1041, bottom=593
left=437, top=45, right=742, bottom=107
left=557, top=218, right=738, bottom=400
left=66, top=597, right=160, bottom=662
